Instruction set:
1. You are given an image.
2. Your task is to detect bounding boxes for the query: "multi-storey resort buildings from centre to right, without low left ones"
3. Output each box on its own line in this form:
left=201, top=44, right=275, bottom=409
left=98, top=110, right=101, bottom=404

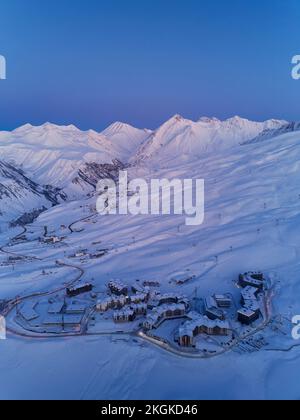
left=96, top=272, right=265, bottom=336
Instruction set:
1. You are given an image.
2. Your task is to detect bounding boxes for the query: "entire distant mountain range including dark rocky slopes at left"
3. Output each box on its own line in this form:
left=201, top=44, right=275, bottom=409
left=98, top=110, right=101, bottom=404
left=0, top=115, right=300, bottom=223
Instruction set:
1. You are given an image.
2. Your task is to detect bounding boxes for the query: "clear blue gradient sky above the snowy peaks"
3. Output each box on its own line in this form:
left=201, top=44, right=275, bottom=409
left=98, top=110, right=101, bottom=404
left=0, top=0, right=300, bottom=130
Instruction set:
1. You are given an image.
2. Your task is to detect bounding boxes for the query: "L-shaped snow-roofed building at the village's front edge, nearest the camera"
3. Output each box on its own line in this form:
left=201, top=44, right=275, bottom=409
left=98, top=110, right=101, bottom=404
left=178, top=314, right=232, bottom=347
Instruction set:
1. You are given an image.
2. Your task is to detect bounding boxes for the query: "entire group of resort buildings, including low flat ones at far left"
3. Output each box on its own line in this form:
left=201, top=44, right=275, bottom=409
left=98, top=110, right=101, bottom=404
left=14, top=272, right=266, bottom=348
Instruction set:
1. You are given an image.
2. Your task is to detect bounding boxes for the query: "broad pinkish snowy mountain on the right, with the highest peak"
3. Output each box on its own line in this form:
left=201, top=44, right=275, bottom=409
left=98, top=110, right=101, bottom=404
left=133, top=115, right=287, bottom=167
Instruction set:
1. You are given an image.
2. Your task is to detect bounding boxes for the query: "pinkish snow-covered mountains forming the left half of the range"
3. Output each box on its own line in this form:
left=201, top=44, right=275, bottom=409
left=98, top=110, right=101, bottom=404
left=0, top=123, right=149, bottom=198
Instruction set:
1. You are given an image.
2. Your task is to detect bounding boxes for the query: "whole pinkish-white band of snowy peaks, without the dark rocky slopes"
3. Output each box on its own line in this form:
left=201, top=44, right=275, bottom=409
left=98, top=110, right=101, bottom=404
left=0, top=116, right=287, bottom=193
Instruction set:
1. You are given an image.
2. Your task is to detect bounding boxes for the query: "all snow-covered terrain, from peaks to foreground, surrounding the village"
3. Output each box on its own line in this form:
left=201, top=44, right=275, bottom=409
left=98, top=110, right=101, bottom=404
left=0, top=116, right=300, bottom=399
